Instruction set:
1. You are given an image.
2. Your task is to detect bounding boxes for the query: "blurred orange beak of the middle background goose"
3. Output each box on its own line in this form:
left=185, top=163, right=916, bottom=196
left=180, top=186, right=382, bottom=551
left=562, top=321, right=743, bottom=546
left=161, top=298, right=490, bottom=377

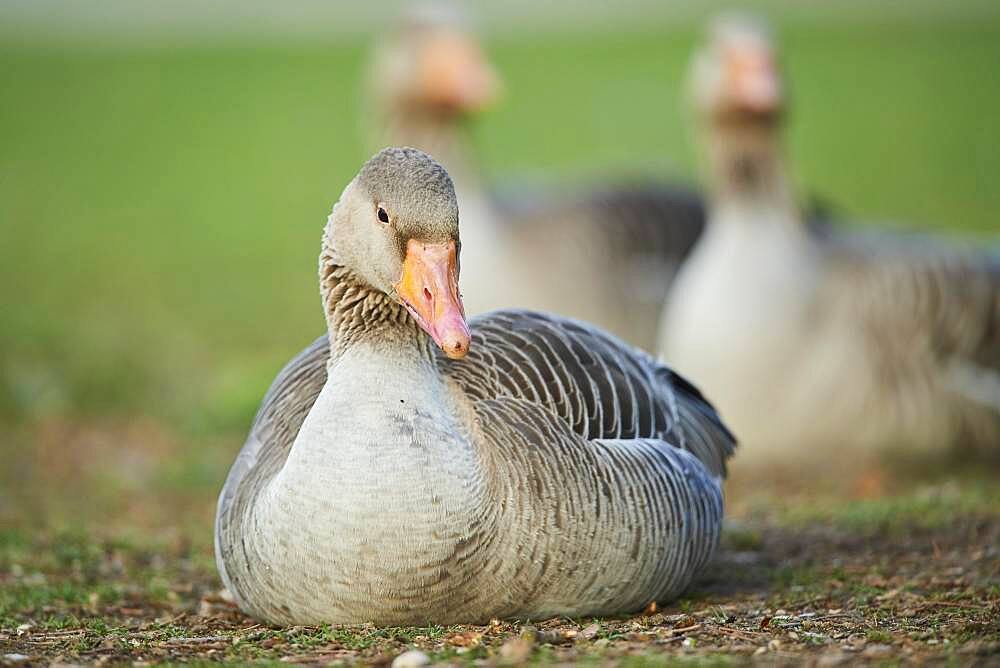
left=421, top=33, right=500, bottom=113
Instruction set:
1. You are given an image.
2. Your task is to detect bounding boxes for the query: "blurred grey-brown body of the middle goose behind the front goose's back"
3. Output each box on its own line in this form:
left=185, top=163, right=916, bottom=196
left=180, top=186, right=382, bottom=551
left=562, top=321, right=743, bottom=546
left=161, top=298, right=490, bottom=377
left=505, top=183, right=705, bottom=350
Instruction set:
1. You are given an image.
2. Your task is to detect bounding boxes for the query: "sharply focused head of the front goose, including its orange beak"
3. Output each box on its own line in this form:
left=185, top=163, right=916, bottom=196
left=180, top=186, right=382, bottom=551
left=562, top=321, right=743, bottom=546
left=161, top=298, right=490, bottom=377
left=323, top=148, right=470, bottom=358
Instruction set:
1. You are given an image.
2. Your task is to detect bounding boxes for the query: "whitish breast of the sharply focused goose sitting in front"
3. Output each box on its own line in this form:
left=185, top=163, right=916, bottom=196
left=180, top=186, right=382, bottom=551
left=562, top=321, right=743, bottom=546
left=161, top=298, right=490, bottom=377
left=235, top=350, right=478, bottom=622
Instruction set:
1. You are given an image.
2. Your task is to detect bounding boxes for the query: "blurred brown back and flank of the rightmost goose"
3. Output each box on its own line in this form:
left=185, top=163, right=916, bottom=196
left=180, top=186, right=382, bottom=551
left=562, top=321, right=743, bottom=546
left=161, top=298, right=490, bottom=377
left=817, top=227, right=1000, bottom=450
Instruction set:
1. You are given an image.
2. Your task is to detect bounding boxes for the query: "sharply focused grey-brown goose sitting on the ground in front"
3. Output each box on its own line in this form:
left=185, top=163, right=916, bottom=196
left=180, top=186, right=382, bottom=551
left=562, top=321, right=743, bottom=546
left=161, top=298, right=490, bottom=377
left=215, top=148, right=734, bottom=625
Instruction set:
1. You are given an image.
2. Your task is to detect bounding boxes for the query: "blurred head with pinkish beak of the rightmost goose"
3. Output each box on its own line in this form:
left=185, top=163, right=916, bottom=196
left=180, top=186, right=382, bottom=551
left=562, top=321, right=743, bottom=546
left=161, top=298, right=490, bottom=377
left=691, top=15, right=785, bottom=125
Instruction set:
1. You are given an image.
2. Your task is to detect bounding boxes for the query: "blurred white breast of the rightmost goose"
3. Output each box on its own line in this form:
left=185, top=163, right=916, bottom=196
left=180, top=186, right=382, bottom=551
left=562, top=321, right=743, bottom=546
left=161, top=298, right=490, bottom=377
left=660, top=212, right=856, bottom=456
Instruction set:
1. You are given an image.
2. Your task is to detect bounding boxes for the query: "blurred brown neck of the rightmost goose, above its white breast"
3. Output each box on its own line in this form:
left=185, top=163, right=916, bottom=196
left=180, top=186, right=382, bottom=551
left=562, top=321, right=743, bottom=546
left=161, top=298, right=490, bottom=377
left=706, top=121, right=798, bottom=223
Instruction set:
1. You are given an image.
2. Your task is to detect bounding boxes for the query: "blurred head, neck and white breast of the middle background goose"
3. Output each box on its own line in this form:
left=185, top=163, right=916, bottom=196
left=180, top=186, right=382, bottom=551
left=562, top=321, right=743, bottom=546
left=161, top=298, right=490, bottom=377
left=363, top=3, right=508, bottom=313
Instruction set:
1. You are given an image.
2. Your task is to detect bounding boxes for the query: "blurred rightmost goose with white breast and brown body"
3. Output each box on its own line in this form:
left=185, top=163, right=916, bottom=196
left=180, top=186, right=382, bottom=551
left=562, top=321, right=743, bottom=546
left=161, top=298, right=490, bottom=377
left=660, top=17, right=1000, bottom=465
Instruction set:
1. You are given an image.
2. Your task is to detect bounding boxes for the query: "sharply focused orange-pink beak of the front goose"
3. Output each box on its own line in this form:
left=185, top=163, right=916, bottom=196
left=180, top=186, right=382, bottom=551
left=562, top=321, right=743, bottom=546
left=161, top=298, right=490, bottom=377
left=393, top=239, right=471, bottom=359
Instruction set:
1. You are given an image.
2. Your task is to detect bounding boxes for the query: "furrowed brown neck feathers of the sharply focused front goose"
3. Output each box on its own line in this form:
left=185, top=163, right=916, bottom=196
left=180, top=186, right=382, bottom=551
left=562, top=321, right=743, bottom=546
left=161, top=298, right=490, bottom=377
left=319, top=235, right=432, bottom=363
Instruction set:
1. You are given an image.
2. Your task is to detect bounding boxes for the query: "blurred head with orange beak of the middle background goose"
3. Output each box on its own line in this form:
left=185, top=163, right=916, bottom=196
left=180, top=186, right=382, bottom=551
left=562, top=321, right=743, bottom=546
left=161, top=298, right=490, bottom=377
left=372, top=4, right=500, bottom=119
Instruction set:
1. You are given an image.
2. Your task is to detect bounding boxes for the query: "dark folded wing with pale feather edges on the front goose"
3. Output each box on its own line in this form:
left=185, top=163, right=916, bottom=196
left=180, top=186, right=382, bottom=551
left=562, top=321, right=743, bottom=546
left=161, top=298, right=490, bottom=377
left=441, top=310, right=735, bottom=476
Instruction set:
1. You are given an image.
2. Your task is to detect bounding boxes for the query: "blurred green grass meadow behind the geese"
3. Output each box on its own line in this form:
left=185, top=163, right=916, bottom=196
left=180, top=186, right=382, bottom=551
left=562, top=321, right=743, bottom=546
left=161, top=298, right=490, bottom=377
left=0, top=5, right=1000, bottom=539
